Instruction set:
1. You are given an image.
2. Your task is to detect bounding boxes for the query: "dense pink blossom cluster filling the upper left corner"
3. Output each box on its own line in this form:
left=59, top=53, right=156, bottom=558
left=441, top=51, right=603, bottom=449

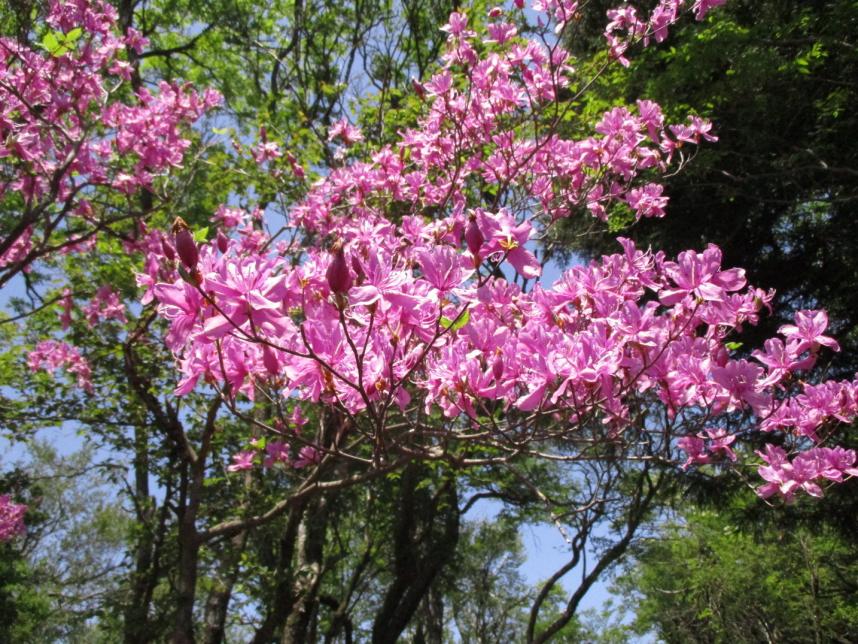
left=0, top=0, right=220, bottom=274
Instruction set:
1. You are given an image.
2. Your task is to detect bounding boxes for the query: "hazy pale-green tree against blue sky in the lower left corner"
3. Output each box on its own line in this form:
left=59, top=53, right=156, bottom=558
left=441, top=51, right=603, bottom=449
left=0, top=441, right=130, bottom=643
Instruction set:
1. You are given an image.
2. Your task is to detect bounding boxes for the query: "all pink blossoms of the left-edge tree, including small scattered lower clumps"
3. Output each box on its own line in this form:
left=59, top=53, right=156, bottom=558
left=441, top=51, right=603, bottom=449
left=0, top=2, right=220, bottom=540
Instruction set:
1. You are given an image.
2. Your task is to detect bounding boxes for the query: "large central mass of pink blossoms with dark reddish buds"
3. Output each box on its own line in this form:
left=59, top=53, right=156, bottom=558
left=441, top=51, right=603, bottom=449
left=140, top=2, right=858, bottom=497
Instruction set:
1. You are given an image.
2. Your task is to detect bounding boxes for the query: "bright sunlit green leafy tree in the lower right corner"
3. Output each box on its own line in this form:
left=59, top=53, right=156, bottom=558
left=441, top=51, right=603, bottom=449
left=619, top=495, right=858, bottom=642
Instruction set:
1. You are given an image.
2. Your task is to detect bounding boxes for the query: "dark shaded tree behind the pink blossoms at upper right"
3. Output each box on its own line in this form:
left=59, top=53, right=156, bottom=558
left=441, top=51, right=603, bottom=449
left=557, top=0, right=858, bottom=373
